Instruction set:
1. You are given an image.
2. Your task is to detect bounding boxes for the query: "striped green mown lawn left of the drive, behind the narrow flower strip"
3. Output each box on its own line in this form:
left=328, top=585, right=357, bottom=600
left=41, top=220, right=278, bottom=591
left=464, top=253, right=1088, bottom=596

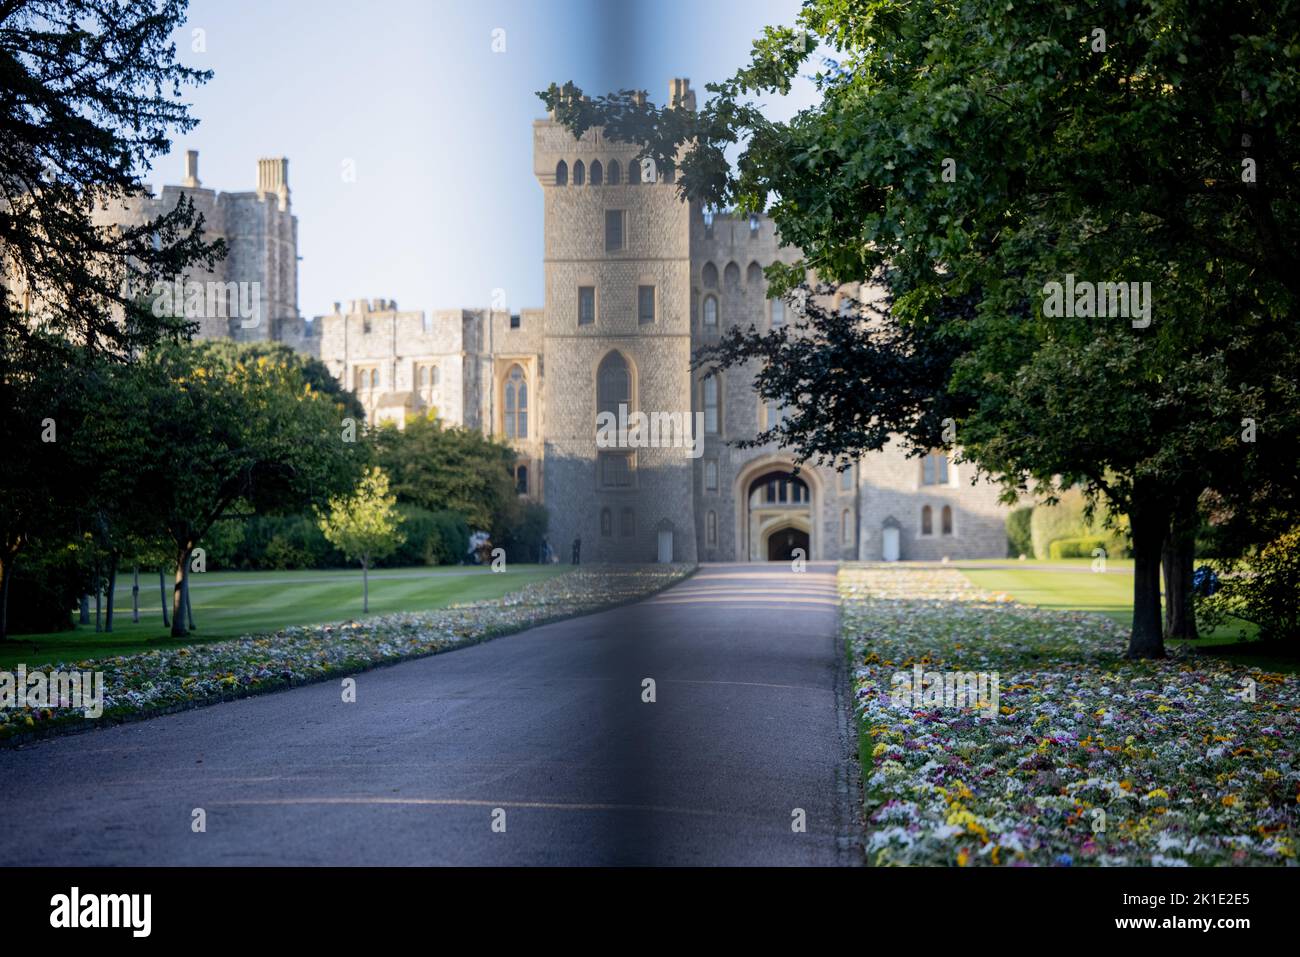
left=0, top=564, right=572, bottom=668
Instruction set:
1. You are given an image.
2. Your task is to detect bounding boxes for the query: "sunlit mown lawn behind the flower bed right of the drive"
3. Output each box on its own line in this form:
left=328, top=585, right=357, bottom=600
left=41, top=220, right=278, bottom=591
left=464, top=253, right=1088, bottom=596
left=956, top=559, right=1300, bottom=674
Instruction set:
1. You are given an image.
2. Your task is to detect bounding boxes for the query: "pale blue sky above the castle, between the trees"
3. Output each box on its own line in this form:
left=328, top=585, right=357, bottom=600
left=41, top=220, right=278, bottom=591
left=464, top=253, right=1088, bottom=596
left=146, top=0, right=814, bottom=316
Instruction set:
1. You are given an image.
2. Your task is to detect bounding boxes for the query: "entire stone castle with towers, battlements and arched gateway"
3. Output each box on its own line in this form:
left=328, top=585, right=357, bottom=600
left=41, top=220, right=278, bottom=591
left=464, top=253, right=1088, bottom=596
left=96, top=79, right=1006, bottom=562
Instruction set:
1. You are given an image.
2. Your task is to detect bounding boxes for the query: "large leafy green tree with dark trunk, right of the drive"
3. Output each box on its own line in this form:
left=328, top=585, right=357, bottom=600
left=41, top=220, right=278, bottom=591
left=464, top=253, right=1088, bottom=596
left=543, top=0, right=1300, bottom=657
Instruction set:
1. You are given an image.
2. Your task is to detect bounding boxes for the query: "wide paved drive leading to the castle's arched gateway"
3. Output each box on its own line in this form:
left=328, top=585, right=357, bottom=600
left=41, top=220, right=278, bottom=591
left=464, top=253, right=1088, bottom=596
left=0, top=564, right=858, bottom=865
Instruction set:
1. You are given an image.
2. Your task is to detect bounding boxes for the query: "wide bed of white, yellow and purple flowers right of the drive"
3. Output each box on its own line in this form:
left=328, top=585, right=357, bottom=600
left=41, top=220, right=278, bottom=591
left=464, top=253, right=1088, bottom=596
left=840, top=567, right=1300, bottom=866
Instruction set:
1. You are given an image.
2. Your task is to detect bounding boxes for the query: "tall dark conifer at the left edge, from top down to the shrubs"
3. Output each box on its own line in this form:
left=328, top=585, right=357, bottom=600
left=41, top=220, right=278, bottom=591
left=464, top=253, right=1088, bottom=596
left=0, top=0, right=215, bottom=638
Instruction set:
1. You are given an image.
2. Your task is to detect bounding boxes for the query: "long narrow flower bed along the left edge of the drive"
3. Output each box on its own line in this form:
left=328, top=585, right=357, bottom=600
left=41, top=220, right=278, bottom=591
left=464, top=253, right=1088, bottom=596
left=0, top=564, right=690, bottom=741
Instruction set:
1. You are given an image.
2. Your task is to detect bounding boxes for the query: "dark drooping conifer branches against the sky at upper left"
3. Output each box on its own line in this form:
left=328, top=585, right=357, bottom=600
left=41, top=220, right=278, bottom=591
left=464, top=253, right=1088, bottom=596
left=0, top=0, right=215, bottom=358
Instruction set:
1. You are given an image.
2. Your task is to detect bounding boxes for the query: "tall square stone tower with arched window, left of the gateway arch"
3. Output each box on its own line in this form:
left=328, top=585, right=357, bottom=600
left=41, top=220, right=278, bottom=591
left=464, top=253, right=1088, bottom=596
left=533, top=80, right=698, bottom=562
